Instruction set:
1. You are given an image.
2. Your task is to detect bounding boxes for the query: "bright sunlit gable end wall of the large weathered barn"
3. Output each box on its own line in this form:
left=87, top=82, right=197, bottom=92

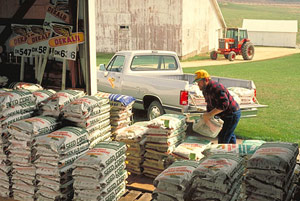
left=182, top=0, right=223, bottom=56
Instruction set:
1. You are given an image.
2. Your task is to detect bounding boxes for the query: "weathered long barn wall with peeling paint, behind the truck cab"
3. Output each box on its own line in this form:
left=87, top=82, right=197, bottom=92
left=96, top=0, right=182, bottom=55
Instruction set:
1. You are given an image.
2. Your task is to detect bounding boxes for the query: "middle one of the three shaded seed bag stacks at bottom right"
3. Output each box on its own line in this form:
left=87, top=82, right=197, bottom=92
left=189, top=154, right=245, bottom=201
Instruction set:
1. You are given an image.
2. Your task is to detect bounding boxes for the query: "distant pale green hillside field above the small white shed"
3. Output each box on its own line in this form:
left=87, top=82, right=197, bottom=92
left=219, top=3, right=300, bottom=44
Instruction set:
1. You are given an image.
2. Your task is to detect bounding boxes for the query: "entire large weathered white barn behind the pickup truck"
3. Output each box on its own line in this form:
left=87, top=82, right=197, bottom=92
left=96, top=0, right=226, bottom=57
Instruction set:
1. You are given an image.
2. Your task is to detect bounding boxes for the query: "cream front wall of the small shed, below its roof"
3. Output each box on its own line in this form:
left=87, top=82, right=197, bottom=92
left=248, top=31, right=297, bottom=47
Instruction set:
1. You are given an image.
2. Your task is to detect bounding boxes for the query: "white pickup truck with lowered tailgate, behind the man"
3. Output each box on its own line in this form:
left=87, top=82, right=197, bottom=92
left=97, top=50, right=263, bottom=119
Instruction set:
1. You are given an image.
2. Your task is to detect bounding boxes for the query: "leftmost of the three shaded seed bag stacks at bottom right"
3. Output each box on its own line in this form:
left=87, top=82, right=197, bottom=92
left=152, top=160, right=199, bottom=201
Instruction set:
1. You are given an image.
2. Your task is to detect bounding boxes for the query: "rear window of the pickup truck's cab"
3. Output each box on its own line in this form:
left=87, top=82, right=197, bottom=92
left=130, top=55, right=178, bottom=71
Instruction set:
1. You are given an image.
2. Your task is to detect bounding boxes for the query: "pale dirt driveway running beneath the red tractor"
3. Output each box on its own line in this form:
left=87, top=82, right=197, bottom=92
left=181, top=47, right=300, bottom=68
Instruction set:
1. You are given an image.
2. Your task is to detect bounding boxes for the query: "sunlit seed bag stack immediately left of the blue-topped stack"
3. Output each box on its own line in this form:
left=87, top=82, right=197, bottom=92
left=62, top=94, right=111, bottom=148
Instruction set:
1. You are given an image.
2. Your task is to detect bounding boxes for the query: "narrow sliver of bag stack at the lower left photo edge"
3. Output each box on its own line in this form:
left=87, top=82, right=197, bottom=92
left=0, top=136, right=12, bottom=197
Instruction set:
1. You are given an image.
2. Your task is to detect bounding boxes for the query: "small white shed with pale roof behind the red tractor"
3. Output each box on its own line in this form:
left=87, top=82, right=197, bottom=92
left=243, top=19, right=298, bottom=47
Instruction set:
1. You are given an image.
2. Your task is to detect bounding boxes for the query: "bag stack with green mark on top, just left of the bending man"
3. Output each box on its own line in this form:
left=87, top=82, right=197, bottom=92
left=142, top=114, right=187, bottom=178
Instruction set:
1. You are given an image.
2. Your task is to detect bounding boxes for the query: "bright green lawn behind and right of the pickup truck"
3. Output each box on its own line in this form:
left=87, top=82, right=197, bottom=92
left=184, top=54, right=300, bottom=145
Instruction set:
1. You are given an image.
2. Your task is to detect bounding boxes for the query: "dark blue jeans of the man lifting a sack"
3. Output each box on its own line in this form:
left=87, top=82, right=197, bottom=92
left=218, top=110, right=241, bottom=144
